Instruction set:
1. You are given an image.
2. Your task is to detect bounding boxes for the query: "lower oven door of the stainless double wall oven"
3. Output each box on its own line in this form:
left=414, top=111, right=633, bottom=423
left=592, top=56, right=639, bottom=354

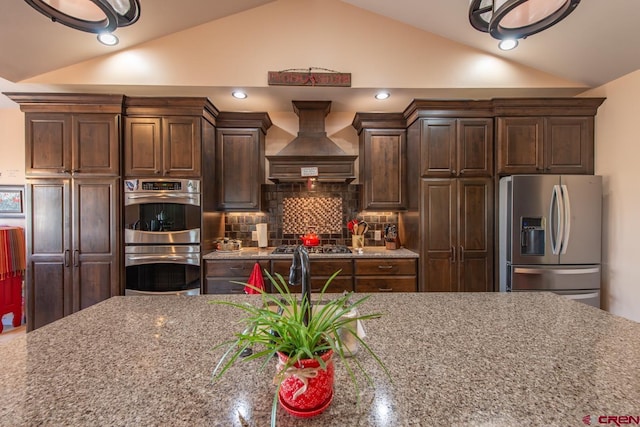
left=124, top=245, right=200, bottom=295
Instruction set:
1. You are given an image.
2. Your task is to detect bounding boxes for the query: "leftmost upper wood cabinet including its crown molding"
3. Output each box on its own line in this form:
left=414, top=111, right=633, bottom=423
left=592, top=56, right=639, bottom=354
left=9, top=93, right=124, bottom=177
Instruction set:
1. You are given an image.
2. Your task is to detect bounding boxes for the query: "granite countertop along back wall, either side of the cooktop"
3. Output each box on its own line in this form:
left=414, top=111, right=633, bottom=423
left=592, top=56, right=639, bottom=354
left=202, top=246, right=418, bottom=260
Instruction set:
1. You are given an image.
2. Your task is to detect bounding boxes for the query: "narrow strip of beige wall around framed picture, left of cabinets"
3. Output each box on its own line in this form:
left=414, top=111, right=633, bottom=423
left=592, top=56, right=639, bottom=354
left=0, top=107, right=25, bottom=231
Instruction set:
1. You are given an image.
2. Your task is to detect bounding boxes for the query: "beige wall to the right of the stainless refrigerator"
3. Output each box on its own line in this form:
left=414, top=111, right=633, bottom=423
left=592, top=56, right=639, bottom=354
left=584, top=70, right=640, bottom=321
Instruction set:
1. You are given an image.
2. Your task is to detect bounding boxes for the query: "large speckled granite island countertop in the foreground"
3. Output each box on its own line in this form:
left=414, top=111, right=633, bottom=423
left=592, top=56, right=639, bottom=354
left=0, top=293, right=640, bottom=427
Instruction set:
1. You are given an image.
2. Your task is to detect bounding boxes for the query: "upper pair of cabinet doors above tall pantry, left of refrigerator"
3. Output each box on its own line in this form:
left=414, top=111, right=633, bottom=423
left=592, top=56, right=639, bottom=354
left=420, top=118, right=493, bottom=177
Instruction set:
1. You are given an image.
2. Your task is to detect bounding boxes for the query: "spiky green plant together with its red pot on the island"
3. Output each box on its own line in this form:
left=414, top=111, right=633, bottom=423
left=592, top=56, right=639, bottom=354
left=211, top=271, right=388, bottom=427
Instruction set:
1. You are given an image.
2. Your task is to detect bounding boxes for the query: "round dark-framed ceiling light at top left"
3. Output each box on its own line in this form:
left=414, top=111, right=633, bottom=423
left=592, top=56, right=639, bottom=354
left=24, top=0, right=140, bottom=34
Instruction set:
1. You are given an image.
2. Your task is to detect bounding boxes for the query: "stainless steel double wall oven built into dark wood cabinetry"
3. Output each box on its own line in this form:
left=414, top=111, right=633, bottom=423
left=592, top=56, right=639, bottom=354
left=124, top=178, right=201, bottom=295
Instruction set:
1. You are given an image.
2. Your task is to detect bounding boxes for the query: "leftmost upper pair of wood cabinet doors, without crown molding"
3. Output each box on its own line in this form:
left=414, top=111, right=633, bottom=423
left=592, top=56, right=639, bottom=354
left=25, top=112, right=120, bottom=177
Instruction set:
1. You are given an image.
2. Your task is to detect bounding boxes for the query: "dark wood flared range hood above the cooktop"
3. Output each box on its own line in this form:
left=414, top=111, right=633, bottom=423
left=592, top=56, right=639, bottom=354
left=267, top=101, right=358, bottom=183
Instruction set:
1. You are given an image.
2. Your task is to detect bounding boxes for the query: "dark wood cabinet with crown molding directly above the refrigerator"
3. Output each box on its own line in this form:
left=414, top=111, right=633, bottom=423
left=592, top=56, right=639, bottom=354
left=496, top=98, right=603, bottom=175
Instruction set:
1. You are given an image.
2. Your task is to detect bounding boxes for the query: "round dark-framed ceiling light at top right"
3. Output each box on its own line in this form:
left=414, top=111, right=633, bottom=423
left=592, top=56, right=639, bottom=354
left=469, top=0, right=580, bottom=46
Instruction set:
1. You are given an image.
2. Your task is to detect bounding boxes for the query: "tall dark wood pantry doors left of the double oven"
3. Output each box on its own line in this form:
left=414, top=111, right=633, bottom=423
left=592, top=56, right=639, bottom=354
left=26, top=178, right=122, bottom=330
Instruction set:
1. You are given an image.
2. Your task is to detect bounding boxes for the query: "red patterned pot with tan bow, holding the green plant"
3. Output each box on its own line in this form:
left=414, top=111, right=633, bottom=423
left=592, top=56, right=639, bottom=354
left=278, top=350, right=334, bottom=418
